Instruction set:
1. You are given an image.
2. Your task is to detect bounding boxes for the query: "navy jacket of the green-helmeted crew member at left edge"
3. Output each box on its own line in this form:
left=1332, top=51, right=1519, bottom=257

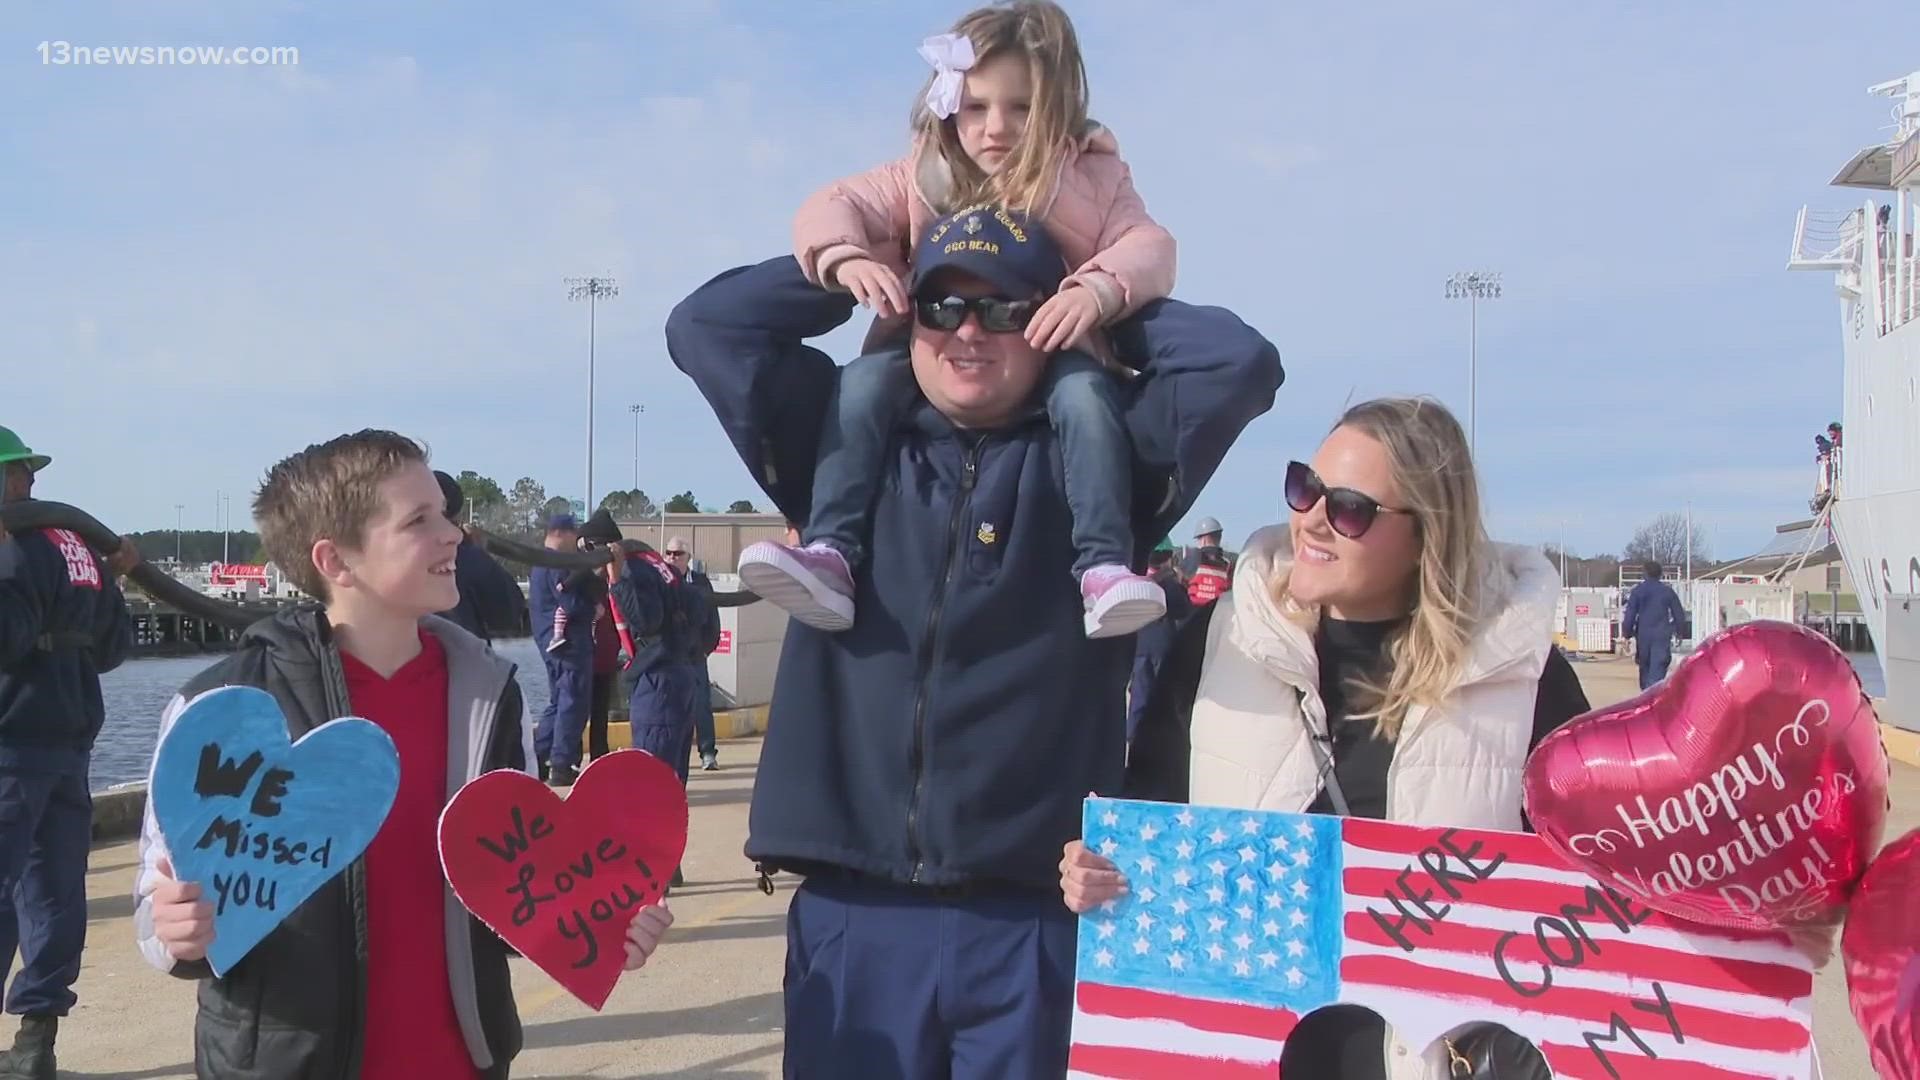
left=0, top=528, right=132, bottom=776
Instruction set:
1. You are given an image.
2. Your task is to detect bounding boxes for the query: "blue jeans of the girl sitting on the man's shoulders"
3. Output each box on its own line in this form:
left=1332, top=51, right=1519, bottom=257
left=803, top=352, right=1133, bottom=577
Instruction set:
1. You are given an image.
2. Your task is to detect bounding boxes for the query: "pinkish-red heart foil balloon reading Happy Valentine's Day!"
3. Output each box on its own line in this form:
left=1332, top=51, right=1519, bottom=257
left=1524, top=621, right=1887, bottom=930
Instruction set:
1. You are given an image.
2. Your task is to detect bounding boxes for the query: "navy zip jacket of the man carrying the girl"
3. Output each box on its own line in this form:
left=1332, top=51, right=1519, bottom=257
left=666, top=258, right=1281, bottom=890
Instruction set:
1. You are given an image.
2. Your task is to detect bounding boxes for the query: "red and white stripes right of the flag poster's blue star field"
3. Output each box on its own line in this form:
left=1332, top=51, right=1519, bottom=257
left=1340, top=821, right=1812, bottom=1080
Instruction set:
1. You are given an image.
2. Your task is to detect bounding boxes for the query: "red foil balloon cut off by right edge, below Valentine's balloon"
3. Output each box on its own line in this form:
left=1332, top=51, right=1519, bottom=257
left=1839, top=830, right=1920, bottom=1080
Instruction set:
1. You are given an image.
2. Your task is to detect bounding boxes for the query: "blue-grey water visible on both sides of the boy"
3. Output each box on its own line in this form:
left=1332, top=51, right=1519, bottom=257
left=90, top=638, right=547, bottom=792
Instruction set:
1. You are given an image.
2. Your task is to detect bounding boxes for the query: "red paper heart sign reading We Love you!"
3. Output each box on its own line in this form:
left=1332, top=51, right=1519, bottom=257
left=440, top=749, right=687, bottom=1011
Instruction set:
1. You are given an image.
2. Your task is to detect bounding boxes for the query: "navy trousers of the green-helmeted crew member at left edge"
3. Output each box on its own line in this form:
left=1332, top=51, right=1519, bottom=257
left=0, top=769, right=94, bottom=1017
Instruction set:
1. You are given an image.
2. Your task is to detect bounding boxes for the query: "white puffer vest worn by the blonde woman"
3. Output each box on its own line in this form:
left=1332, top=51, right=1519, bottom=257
left=1190, top=525, right=1559, bottom=1080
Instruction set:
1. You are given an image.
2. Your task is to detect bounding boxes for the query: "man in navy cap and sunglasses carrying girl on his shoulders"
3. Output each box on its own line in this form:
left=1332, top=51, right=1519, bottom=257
left=666, top=208, right=1281, bottom=1080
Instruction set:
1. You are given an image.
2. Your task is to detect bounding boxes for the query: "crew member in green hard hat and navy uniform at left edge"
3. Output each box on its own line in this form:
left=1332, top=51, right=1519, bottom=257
left=0, top=427, right=140, bottom=1080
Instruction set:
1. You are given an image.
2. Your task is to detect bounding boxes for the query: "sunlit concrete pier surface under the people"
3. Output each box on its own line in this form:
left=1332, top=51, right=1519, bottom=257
left=26, top=661, right=1920, bottom=1080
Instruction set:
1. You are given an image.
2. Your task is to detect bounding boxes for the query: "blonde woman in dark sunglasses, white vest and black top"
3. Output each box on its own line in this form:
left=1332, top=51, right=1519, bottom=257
left=1060, top=398, right=1588, bottom=1080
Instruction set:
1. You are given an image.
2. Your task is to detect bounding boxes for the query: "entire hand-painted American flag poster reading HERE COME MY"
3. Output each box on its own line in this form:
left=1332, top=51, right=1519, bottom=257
left=1069, top=798, right=1812, bottom=1080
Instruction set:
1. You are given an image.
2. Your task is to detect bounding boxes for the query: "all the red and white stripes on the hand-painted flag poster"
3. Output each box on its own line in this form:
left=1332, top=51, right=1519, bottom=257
left=1068, top=819, right=1814, bottom=1080
